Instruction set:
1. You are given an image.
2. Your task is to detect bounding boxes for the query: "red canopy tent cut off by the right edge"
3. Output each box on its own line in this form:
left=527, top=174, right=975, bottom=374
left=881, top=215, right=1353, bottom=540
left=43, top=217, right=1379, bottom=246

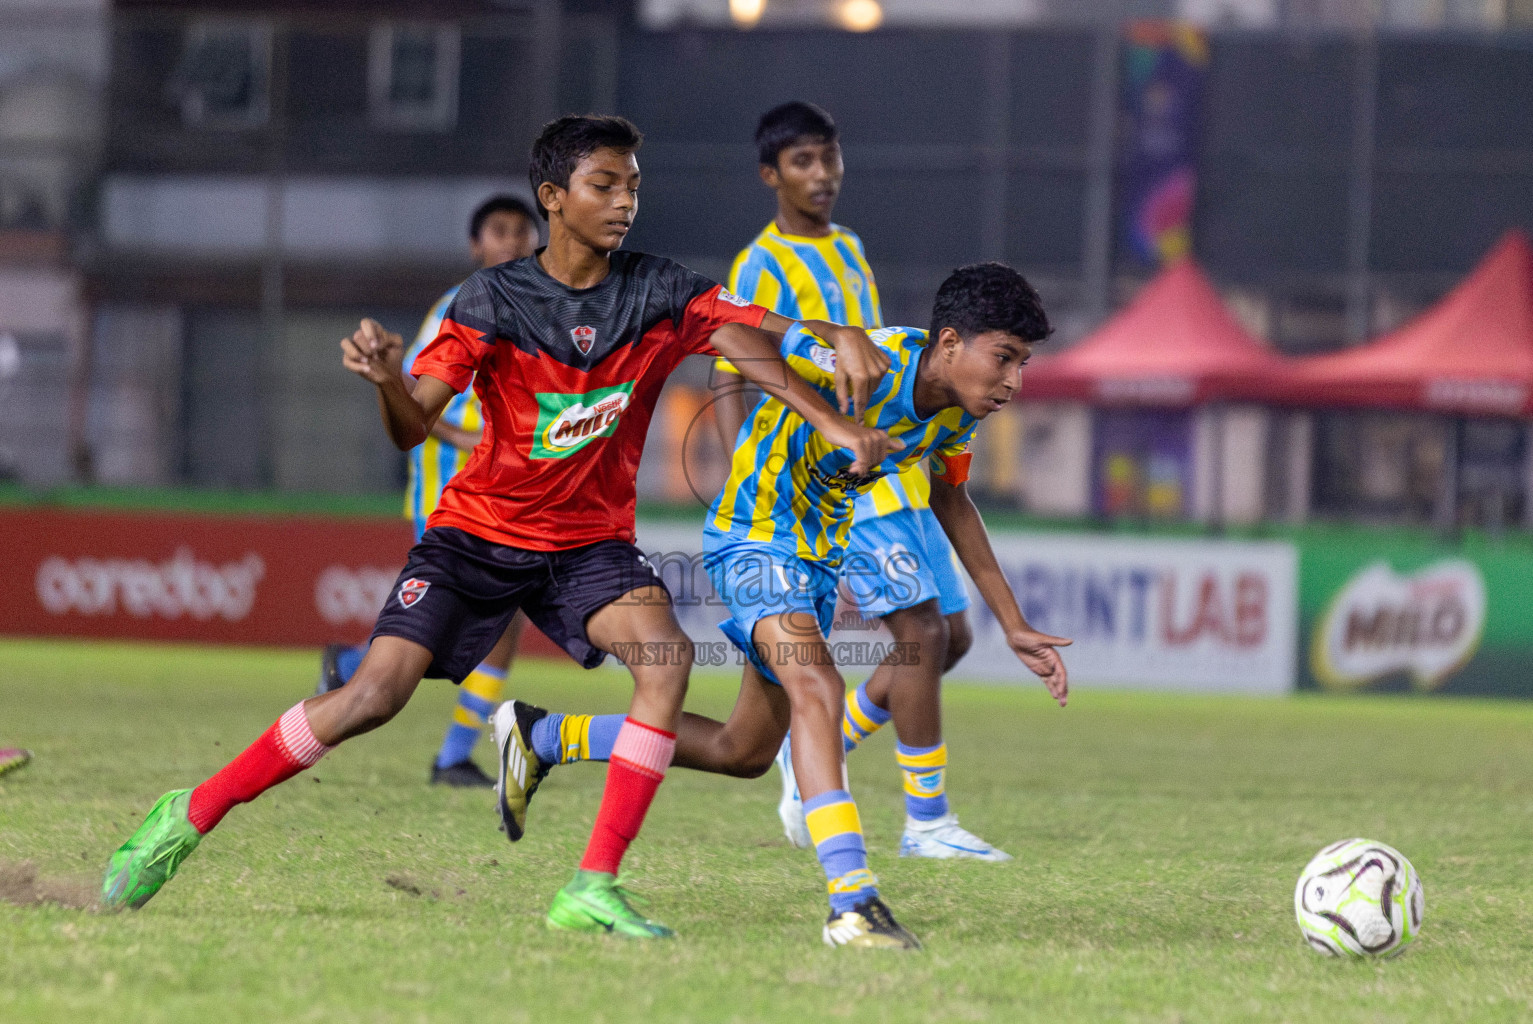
left=1286, top=230, right=1533, bottom=415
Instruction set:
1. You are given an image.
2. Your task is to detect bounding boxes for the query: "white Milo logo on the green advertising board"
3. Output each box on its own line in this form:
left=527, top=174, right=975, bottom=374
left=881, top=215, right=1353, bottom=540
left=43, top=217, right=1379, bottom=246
left=1309, top=558, right=1485, bottom=690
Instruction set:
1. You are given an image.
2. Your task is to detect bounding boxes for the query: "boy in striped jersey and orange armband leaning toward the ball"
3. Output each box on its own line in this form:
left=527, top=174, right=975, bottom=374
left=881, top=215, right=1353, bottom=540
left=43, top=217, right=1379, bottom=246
left=518, top=264, right=1070, bottom=949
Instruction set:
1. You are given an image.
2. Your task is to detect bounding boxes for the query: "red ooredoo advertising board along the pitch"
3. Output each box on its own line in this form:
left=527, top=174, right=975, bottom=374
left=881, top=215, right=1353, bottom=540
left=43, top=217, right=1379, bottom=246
left=0, top=507, right=564, bottom=656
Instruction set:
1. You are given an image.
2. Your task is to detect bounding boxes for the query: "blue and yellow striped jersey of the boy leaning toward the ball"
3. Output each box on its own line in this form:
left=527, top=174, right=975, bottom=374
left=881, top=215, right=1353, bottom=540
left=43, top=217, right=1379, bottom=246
left=704, top=327, right=978, bottom=566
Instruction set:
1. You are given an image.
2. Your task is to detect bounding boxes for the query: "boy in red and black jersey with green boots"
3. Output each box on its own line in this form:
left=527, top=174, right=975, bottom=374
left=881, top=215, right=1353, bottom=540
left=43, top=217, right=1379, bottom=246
left=103, top=117, right=898, bottom=937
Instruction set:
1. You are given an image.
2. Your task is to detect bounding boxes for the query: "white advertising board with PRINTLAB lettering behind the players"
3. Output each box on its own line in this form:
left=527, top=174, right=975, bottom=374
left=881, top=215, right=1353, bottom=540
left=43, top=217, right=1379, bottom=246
left=639, top=523, right=1298, bottom=694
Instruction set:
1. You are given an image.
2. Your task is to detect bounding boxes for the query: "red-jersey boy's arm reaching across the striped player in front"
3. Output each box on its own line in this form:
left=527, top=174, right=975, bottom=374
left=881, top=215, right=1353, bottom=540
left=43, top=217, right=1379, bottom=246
left=710, top=314, right=904, bottom=475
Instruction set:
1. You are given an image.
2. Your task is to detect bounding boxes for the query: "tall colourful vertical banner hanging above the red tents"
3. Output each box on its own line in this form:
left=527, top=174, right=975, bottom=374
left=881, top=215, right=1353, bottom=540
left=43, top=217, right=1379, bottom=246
left=1119, top=21, right=1208, bottom=268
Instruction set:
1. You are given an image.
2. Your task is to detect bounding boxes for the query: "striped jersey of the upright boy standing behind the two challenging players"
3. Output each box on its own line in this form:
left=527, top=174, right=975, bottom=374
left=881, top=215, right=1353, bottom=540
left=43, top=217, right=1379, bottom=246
left=714, top=221, right=931, bottom=520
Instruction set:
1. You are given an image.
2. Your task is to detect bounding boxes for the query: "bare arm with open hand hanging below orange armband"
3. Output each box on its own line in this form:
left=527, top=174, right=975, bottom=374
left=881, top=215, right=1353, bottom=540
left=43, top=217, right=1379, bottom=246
left=931, top=474, right=1070, bottom=707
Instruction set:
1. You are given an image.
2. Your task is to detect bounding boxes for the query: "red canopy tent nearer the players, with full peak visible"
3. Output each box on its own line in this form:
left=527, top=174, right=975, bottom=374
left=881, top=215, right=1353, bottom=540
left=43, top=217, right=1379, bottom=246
left=1021, top=259, right=1288, bottom=408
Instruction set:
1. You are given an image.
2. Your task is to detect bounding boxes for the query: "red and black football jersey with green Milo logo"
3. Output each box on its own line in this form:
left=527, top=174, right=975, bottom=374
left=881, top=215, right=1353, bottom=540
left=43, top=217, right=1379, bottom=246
left=412, top=253, right=767, bottom=550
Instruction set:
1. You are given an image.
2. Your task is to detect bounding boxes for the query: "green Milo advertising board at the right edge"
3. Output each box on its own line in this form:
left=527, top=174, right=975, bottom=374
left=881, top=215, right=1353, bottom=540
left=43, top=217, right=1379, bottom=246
left=1300, top=527, right=1533, bottom=697
